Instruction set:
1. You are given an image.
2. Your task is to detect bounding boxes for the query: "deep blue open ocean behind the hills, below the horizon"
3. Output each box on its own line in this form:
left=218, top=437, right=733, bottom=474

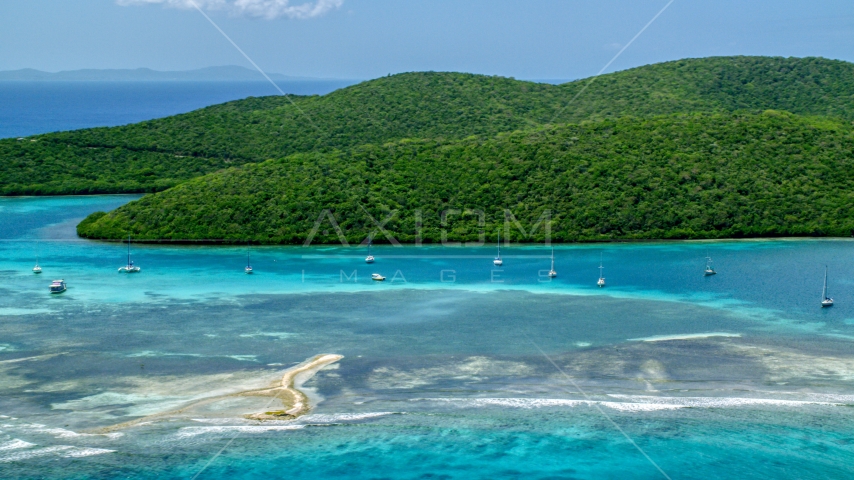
left=0, top=80, right=356, bottom=138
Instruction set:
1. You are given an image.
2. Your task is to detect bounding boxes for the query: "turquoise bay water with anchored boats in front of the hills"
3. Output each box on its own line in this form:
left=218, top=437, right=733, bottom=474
left=0, top=196, right=854, bottom=478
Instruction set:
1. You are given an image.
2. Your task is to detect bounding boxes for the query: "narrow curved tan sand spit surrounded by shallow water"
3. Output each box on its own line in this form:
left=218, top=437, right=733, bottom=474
left=96, top=354, right=344, bottom=433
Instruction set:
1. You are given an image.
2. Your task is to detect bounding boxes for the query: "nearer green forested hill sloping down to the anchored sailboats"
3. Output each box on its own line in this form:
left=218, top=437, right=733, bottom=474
left=78, top=111, right=854, bottom=243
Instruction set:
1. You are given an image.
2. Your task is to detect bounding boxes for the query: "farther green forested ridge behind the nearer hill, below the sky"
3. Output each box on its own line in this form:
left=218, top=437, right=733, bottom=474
left=5, top=57, right=854, bottom=195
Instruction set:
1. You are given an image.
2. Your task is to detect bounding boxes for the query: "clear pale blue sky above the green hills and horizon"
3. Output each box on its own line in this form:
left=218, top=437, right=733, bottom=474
left=0, top=0, right=854, bottom=79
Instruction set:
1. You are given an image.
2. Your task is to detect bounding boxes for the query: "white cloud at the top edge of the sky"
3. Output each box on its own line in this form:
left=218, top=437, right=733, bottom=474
left=116, top=0, right=344, bottom=20
